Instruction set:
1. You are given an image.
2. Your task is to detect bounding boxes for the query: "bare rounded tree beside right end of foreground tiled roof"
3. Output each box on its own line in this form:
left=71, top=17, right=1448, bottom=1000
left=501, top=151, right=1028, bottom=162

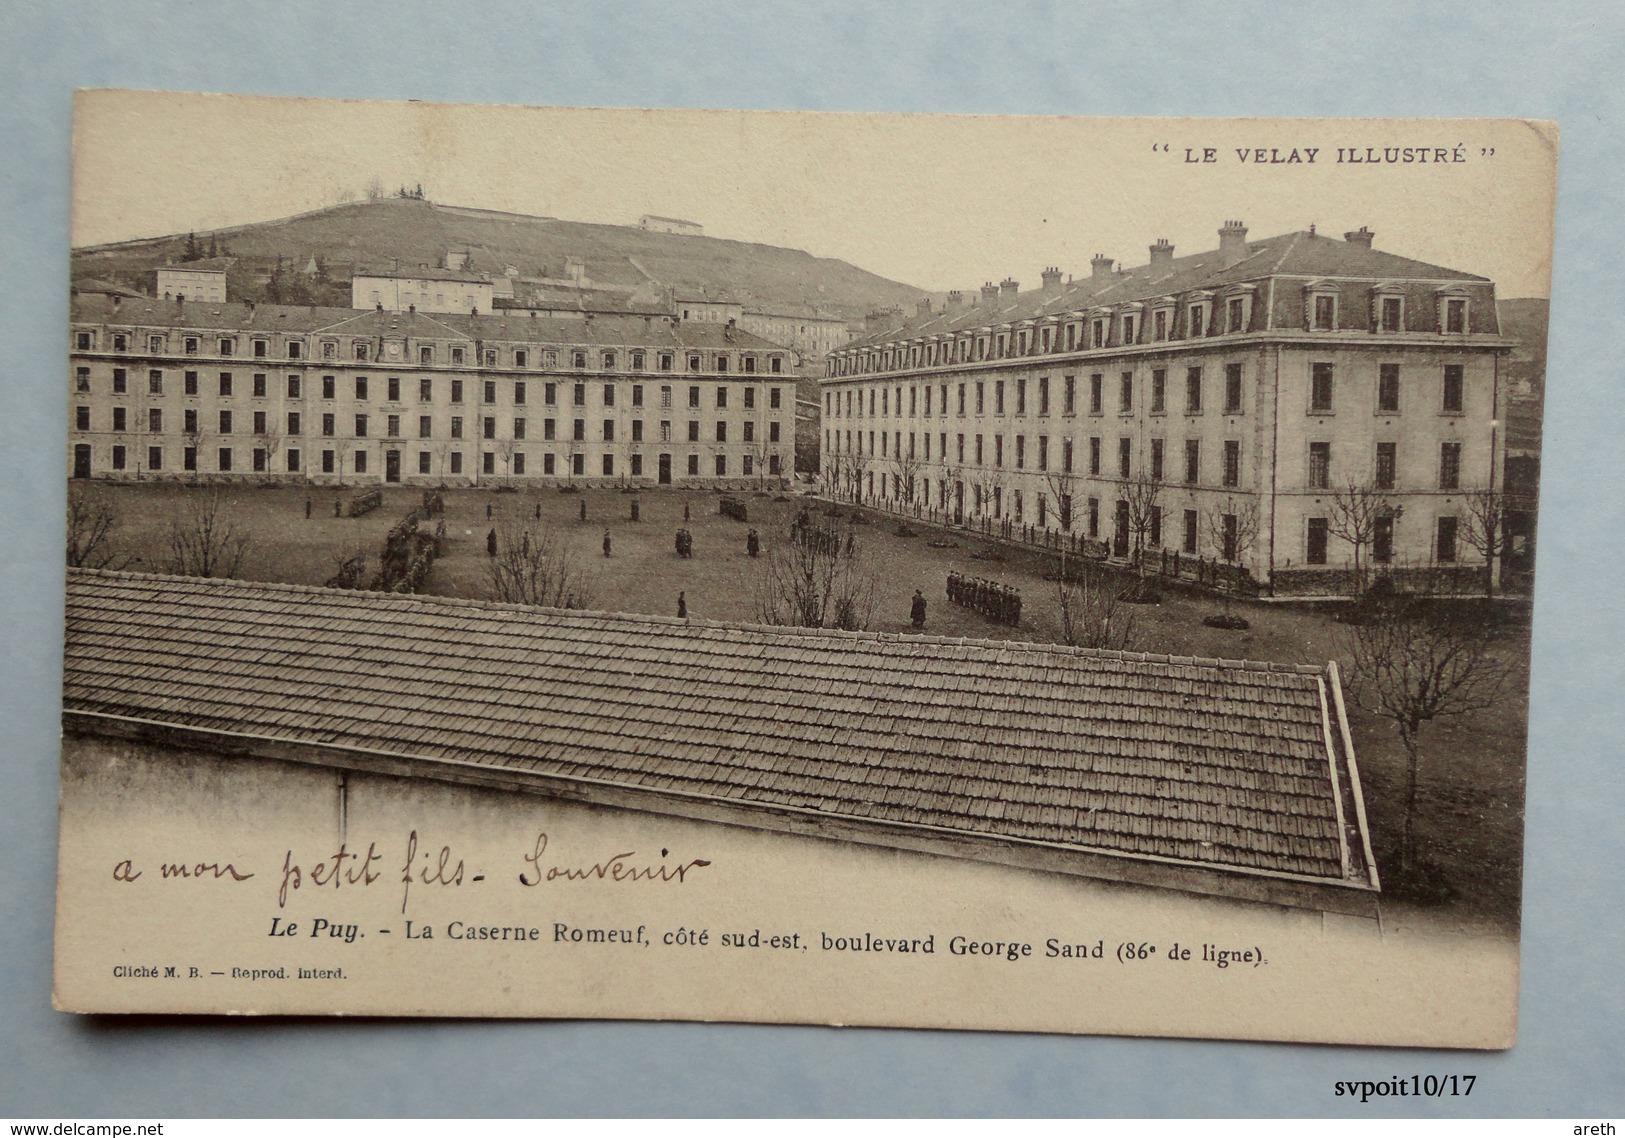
left=1344, top=598, right=1511, bottom=870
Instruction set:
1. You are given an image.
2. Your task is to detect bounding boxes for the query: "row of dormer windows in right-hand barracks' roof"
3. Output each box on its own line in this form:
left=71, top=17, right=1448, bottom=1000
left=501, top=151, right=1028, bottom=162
left=826, top=285, right=1469, bottom=377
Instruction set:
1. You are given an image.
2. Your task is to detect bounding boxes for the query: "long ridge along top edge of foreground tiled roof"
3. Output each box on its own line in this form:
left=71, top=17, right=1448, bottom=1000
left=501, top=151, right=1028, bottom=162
left=67, top=566, right=1326, bottom=676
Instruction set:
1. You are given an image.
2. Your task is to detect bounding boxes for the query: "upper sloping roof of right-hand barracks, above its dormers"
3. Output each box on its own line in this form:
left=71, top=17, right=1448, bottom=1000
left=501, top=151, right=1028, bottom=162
left=847, top=231, right=1490, bottom=350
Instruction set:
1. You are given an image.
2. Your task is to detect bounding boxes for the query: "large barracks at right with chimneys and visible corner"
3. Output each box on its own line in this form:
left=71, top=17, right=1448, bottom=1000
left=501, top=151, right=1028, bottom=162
left=822, top=221, right=1511, bottom=593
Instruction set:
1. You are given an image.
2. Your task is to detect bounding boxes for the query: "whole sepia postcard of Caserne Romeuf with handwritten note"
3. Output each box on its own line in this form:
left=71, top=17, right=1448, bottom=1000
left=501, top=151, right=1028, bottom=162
left=55, top=91, right=1557, bottom=1049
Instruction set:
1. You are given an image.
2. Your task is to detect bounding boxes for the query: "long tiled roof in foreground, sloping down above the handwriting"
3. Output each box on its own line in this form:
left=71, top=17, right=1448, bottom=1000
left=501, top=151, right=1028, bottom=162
left=63, top=571, right=1375, bottom=891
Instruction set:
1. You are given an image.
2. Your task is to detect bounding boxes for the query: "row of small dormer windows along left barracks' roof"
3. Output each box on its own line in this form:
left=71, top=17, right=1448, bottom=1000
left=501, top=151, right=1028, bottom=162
left=73, top=332, right=785, bottom=376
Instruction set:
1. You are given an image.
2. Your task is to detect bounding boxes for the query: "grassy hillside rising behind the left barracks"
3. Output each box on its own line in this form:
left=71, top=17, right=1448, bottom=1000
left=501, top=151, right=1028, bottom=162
left=73, top=198, right=921, bottom=319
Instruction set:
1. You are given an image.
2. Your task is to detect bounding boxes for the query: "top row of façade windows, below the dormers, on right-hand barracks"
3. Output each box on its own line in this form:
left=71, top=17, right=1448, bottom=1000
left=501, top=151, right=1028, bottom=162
left=824, top=363, right=1466, bottom=418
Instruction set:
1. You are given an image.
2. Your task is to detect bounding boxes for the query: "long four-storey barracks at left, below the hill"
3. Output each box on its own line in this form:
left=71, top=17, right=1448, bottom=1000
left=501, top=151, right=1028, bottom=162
left=68, top=293, right=795, bottom=486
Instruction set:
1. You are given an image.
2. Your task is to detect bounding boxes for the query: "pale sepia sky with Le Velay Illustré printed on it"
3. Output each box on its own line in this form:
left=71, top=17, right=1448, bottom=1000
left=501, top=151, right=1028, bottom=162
left=73, top=91, right=1557, bottom=298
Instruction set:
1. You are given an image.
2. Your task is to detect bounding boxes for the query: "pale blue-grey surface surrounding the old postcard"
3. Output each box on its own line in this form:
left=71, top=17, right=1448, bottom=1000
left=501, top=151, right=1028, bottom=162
left=0, top=0, right=1625, bottom=1117
